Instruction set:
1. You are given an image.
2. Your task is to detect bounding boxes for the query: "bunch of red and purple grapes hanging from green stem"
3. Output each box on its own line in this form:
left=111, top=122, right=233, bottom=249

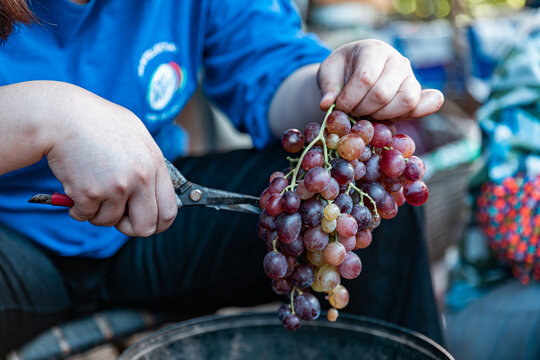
left=257, top=106, right=428, bottom=331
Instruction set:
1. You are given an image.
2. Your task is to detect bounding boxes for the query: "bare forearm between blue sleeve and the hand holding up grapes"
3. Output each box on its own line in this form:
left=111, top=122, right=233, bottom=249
left=269, top=64, right=324, bottom=138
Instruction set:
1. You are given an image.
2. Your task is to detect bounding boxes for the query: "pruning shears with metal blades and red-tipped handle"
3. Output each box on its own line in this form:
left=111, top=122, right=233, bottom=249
left=28, top=159, right=261, bottom=214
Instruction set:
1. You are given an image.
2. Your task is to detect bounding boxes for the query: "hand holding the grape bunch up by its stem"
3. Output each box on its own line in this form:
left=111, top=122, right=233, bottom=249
left=318, top=40, right=444, bottom=120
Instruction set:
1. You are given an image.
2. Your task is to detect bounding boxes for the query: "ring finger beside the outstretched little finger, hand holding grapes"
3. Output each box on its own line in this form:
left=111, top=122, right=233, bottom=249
left=371, top=75, right=422, bottom=120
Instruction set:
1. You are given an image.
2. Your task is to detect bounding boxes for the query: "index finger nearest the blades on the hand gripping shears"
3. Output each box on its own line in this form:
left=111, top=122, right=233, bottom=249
left=156, top=163, right=178, bottom=233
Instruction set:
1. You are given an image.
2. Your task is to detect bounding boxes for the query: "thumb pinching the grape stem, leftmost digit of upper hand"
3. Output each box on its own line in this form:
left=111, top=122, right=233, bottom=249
left=317, top=55, right=345, bottom=111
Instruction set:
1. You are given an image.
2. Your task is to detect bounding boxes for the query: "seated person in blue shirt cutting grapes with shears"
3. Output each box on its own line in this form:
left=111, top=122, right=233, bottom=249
left=0, top=0, right=443, bottom=353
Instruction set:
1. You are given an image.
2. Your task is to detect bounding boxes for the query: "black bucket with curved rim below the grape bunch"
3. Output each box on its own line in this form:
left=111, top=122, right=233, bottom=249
left=120, top=312, right=453, bottom=360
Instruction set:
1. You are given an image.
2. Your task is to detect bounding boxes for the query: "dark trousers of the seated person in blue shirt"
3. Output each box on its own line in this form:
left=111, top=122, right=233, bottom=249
left=0, top=148, right=442, bottom=354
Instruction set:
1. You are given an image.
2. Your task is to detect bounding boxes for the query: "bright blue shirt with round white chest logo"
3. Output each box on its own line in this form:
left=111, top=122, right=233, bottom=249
left=0, top=0, right=329, bottom=258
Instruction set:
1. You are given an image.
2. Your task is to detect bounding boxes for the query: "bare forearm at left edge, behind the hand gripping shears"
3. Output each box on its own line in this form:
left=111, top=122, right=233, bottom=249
left=0, top=81, right=57, bottom=174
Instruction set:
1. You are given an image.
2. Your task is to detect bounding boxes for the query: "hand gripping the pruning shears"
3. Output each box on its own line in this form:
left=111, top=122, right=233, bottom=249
left=44, top=83, right=178, bottom=236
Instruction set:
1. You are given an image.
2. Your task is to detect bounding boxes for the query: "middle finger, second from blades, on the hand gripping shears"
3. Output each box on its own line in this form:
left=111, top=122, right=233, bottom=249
left=116, top=174, right=158, bottom=237
